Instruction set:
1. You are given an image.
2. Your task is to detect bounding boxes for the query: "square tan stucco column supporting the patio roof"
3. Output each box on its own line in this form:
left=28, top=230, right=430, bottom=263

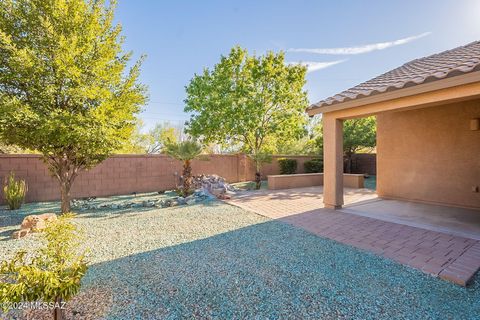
left=323, top=113, right=343, bottom=209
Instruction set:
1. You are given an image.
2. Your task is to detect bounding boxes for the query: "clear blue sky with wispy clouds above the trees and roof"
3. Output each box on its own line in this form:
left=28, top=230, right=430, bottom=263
left=116, top=0, right=480, bottom=130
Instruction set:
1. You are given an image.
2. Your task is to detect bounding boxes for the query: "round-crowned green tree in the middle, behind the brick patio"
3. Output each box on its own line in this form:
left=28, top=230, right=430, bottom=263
left=185, top=47, right=308, bottom=187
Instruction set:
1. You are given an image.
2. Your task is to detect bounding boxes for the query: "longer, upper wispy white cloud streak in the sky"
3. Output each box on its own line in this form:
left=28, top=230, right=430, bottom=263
left=287, top=32, right=431, bottom=55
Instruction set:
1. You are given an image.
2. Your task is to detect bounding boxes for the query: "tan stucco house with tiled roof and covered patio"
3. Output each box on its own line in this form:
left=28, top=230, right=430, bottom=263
left=307, top=41, right=480, bottom=209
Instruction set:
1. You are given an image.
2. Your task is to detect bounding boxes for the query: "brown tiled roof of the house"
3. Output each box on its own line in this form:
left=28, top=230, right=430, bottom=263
left=308, top=41, right=480, bottom=110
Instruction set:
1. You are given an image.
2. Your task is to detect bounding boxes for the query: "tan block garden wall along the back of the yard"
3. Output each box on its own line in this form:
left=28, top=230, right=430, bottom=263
left=0, top=154, right=376, bottom=203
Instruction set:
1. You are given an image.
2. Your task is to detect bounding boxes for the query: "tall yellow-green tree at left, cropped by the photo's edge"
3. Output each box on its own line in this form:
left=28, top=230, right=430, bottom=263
left=0, top=0, right=146, bottom=212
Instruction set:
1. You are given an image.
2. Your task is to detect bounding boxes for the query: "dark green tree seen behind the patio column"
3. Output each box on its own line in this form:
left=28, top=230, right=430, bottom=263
left=314, top=117, right=377, bottom=172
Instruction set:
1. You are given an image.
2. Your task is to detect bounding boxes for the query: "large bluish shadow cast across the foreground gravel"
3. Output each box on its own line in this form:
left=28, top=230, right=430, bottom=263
left=84, top=220, right=480, bottom=319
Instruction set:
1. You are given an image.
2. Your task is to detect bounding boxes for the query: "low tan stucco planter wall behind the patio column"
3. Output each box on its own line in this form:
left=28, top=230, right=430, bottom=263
left=267, top=173, right=364, bottom=190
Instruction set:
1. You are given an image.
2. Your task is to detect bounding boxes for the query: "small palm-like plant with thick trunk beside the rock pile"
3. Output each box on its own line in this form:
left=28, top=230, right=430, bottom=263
left=163, top=140, right=203, bottom=196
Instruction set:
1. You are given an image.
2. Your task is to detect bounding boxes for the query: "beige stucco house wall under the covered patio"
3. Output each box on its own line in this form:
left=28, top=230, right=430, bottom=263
left=377, top=100, right=480, bottom=208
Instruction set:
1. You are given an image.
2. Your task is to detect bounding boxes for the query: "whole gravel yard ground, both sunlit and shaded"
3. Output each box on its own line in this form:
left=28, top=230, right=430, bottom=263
left=0, top=195, right=480, bottom=319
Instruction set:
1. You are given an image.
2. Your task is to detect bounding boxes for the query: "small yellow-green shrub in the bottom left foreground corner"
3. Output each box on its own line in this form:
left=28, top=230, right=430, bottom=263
left=0, top=214, right=87, bottom=320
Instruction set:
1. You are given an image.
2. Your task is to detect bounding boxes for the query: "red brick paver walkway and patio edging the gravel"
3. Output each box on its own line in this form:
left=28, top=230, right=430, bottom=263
left=229, top=190, right=480, bottom=286
